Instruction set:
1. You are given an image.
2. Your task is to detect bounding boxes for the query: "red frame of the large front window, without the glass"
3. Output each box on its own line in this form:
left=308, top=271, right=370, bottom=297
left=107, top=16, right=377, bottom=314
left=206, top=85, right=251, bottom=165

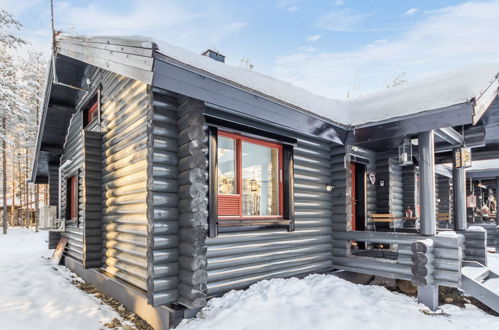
left=216, top=131, right=284, bottom=219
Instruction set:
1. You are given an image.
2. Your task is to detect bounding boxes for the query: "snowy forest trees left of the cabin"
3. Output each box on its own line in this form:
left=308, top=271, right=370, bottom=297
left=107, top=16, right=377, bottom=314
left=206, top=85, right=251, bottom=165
left=0, top=10, right=49, bottom=234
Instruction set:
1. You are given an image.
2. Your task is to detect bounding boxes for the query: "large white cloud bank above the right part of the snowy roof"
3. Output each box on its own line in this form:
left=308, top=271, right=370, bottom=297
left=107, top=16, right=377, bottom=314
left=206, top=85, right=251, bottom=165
left=274, top=1, right=499, bottom=97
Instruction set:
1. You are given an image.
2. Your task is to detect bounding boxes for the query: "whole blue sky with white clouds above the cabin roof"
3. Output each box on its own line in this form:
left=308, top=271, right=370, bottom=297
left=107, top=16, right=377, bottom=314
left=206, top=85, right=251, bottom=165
left=0, top=0, right=499, bottom=98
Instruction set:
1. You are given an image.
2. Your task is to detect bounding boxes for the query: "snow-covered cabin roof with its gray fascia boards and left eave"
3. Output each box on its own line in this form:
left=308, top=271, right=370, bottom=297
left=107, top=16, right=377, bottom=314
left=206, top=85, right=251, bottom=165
left=31, top=34, right=499, bottom=183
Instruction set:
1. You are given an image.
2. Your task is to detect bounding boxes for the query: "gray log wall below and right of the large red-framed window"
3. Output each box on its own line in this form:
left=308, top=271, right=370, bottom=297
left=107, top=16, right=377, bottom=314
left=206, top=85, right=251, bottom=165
left=207, top=120, right=334, bottom=295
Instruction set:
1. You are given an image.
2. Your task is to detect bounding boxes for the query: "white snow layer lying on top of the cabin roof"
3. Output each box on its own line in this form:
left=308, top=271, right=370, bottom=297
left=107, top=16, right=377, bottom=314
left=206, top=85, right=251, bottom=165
left=59, top=35, right=499, bottom=126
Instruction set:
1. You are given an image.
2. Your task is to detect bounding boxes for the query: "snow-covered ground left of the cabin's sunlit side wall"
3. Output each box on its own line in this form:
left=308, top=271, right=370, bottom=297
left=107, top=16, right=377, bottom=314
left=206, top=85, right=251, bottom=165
left=0, top=228, right=127, bottom=330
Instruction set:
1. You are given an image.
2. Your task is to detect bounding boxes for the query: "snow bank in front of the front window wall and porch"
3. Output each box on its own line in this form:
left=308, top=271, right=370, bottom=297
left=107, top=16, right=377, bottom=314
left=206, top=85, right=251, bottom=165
left=177, top=275, right=499, bottom=330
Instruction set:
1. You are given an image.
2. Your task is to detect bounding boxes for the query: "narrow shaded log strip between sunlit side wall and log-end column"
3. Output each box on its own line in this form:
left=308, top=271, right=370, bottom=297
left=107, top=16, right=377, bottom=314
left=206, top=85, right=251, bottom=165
left=147, top=90, right=183, bottom=306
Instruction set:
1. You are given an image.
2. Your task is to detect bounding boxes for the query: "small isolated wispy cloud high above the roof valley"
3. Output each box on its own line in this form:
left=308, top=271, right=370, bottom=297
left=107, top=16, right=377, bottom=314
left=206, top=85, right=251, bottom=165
left=317, top=8, right=368, bottom=31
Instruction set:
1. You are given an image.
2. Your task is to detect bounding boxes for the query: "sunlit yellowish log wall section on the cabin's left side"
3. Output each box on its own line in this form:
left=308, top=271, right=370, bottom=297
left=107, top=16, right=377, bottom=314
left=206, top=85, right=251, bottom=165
left=101, top=72, right=154, bottom=291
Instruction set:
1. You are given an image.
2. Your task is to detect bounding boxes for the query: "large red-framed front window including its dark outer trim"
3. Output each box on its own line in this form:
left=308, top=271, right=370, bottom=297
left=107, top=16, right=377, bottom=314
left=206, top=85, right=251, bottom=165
left=210, top=128, right=293, bottom=236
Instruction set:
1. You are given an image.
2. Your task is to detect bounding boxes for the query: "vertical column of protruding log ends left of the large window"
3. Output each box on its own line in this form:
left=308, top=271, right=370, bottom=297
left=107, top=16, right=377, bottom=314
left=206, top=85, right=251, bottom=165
left=177, top=98, right=208, bottom=308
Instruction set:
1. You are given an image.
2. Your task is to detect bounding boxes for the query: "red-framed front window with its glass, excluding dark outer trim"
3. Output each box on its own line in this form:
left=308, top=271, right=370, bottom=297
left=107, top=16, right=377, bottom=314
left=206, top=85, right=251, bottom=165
left=217, top=131, right=283, bottom=218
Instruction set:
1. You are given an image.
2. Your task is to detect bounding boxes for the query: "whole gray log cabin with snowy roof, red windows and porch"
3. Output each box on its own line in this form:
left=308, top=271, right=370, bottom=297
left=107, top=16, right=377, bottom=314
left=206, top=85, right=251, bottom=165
left=32, top=36, right=499, bottom=328
